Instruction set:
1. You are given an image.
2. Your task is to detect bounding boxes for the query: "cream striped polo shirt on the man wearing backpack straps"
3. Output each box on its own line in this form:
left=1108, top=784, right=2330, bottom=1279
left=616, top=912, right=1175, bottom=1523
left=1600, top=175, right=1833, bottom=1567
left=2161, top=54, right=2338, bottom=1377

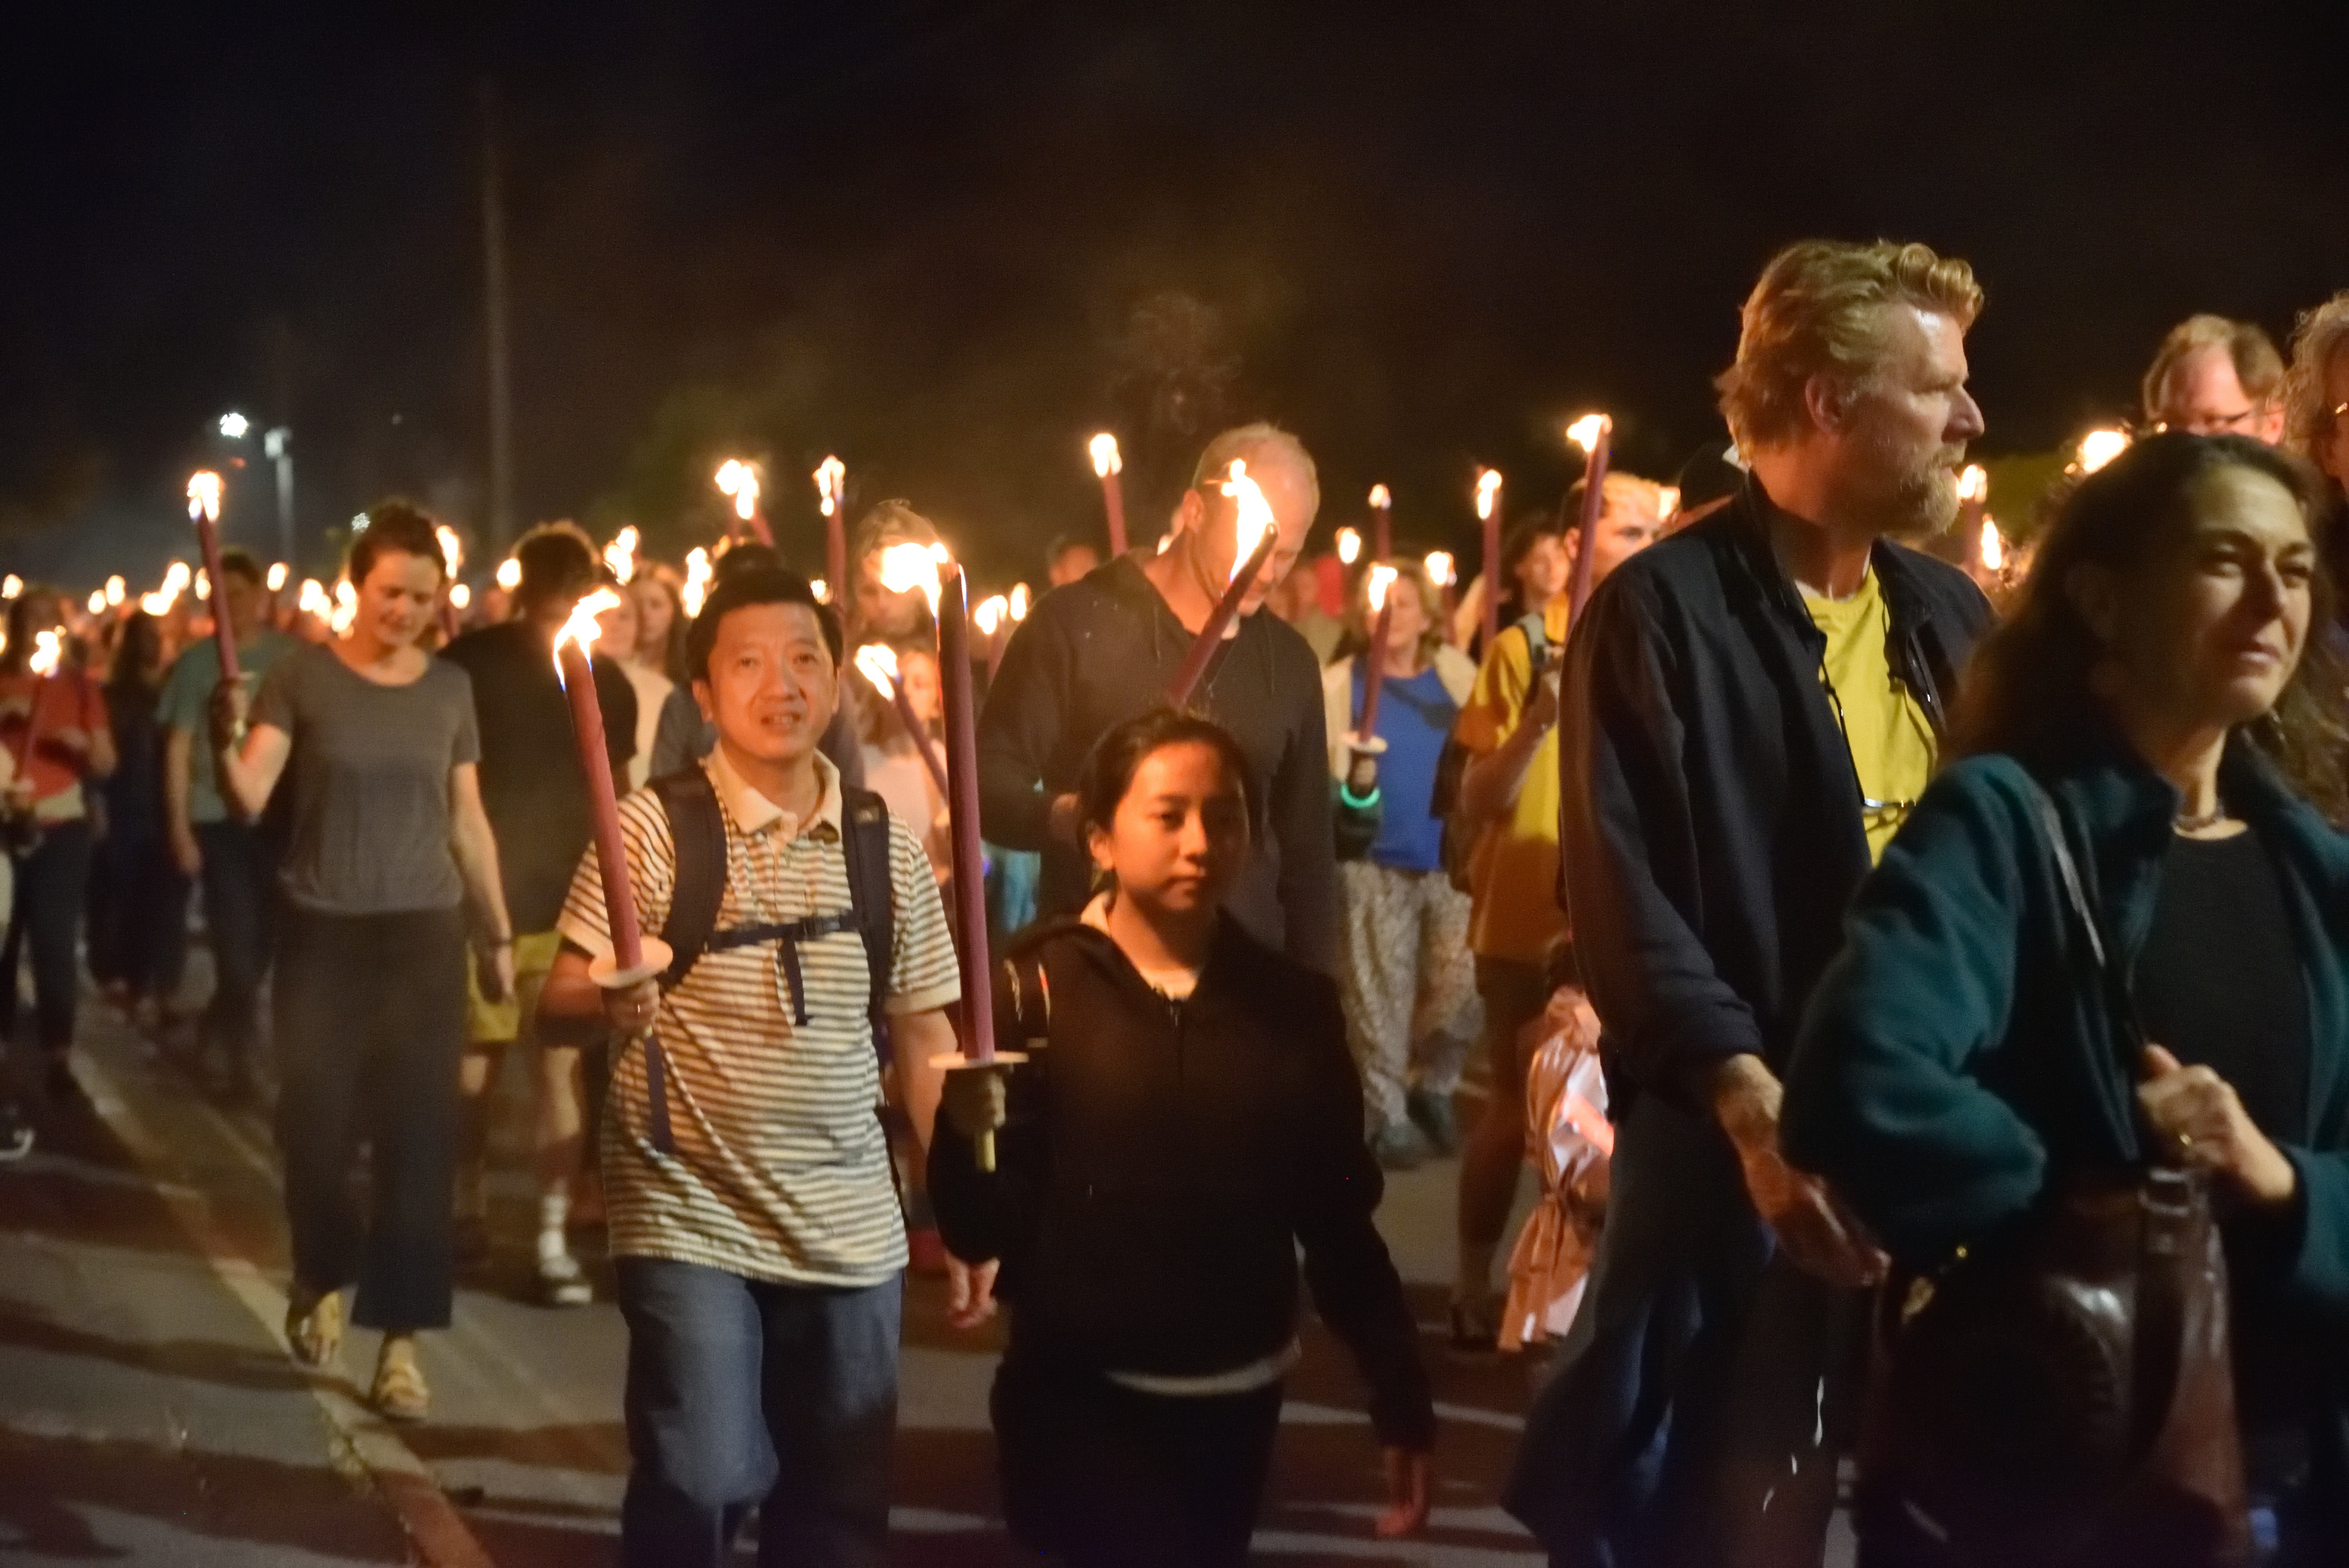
left=559, top=747, right=961, bottom=1286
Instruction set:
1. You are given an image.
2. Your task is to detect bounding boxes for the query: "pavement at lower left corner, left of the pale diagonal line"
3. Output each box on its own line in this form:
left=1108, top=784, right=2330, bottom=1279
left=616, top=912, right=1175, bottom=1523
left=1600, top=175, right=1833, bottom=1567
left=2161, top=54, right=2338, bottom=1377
left=0, top=1028, right=421, bottom=1568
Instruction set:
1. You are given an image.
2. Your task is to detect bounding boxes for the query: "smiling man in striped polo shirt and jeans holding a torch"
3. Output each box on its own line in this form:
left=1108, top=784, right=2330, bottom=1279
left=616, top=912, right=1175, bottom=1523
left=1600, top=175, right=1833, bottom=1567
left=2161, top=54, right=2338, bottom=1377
left=543, top=570, right=959, bottom=1568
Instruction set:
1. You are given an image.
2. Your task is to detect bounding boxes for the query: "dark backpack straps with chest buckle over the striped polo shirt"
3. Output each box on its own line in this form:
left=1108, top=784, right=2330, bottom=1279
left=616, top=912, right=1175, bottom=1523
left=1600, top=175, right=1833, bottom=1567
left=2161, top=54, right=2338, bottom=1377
left=643, top=765, right=897, bottom=1155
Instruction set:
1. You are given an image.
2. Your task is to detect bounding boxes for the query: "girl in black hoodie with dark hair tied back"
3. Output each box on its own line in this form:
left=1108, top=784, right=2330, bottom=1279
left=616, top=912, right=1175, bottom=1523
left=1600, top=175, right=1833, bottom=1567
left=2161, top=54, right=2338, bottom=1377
left=930, top=711, right=1435, bottom=1568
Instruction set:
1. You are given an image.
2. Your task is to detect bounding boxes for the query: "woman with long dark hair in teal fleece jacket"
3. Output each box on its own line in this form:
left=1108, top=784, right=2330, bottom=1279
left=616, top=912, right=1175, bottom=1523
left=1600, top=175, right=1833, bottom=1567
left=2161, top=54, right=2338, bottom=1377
left=1780, top=434, right=2349, bottom=1568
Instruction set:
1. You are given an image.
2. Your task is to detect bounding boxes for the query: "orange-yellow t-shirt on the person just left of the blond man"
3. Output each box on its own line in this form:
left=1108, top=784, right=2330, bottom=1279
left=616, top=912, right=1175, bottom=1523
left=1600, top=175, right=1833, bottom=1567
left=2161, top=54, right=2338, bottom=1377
left=1452, top=603, right=1567, bottom=965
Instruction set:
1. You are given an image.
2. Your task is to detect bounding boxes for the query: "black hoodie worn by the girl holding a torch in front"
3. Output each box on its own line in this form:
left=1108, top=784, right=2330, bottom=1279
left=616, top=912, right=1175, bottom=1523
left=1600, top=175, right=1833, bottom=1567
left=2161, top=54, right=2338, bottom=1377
left=930, top=920, right=1435, bottom=1448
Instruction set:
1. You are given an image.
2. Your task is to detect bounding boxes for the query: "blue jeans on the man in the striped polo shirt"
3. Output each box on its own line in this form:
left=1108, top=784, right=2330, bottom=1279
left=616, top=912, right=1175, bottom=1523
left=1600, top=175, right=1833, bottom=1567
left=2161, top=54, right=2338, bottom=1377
left=618, top=1258, right=904, bottom=1568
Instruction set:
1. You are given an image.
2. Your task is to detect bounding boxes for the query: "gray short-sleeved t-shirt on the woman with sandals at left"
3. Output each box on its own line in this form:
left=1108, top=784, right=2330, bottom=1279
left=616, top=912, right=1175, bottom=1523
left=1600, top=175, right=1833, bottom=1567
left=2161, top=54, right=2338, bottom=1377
left=251, top=645, right=481, bottom=916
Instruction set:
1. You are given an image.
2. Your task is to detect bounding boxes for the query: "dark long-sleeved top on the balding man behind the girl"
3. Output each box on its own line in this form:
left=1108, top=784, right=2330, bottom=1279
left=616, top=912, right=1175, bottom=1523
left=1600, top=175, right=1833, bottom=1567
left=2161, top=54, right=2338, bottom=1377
left=980, top=556, right=1339, bottom=974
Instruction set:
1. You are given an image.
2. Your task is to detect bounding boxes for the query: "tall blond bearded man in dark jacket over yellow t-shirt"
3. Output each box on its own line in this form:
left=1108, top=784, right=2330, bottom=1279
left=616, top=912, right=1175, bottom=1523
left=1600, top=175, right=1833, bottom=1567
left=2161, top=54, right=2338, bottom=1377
left=1506, top=242, right=1990, bottom=1568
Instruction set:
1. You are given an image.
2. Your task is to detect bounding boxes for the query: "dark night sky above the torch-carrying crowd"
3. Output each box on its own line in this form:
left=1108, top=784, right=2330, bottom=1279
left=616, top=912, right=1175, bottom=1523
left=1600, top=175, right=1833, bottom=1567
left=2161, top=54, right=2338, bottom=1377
left=0, top=0, right=2349, bottom=589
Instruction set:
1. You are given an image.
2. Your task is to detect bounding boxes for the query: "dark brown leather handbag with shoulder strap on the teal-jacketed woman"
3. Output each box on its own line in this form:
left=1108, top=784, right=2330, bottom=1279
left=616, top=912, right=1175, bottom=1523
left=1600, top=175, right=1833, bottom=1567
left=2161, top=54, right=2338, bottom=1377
left=1856, top=784, right=2250, bottom=1568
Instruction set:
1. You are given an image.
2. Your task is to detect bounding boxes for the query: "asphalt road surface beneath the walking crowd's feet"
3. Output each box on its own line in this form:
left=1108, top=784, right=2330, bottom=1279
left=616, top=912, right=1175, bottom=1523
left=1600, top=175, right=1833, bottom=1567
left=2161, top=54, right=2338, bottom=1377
left=0, top=971, right=1538, bottom=1568
